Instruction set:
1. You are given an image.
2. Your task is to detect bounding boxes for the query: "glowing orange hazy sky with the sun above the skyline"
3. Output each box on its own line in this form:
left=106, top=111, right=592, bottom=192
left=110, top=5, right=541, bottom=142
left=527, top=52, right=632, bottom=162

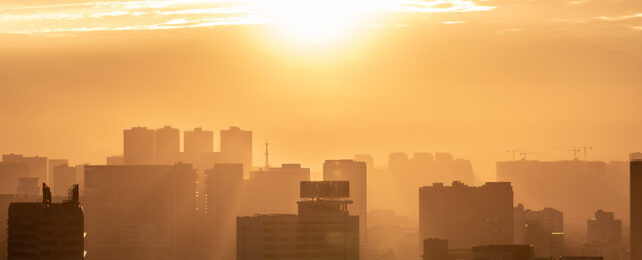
left=0, top=0, right=642, bottom=179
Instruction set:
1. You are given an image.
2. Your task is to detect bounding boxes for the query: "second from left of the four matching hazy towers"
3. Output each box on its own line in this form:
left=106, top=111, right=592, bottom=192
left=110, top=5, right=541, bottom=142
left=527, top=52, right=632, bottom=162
left=154, top=126, right=181, bottom=165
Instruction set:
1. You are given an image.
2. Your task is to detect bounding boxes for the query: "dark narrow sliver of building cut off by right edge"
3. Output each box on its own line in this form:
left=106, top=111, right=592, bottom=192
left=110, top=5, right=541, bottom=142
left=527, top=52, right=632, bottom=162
left=629, top=154, right=642, bottom=260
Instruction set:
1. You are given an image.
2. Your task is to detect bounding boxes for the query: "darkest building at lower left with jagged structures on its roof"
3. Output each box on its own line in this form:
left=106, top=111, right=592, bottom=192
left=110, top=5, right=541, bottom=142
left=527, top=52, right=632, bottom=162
left=7, top=183, right=85, bottom=260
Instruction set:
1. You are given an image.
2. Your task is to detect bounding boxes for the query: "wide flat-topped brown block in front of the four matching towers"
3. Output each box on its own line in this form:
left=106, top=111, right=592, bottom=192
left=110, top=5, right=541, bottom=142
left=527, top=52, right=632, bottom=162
left=84, top=164, right=198, bottom=259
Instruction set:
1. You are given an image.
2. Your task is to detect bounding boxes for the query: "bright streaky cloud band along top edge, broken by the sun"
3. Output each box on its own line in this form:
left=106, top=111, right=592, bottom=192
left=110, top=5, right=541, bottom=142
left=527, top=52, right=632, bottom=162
left=0, top=0, right=494, bottom=34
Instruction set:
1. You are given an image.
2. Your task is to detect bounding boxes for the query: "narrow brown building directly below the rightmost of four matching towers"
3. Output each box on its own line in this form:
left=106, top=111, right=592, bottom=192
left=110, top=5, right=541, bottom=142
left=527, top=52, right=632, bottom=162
left=205, top=163, right=246, bottom=259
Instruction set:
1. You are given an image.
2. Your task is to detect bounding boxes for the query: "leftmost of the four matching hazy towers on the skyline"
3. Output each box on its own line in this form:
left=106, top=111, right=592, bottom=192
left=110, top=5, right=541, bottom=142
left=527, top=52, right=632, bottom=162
left=123, top=127, right=155, bottom=165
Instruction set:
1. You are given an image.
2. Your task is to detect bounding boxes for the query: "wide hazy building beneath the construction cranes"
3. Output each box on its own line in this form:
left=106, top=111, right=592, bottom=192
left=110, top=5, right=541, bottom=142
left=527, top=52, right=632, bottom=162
left=496, top=160, right=626, bottom=229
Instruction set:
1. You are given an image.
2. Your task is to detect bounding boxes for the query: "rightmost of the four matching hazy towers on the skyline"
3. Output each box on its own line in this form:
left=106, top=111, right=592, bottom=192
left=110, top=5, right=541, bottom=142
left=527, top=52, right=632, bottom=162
left=221, top=126, right=252, bottom=177
